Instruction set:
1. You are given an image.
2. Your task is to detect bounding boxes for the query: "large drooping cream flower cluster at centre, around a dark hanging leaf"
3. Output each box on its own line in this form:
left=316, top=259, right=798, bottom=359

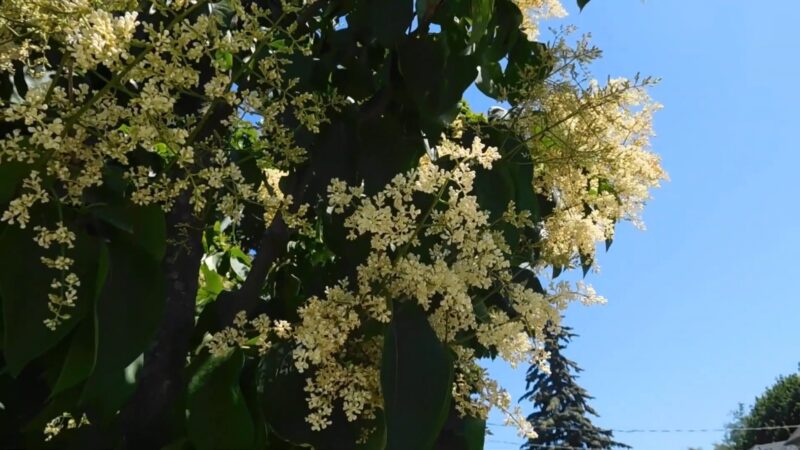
left=294, top=139, right=578, bottom=434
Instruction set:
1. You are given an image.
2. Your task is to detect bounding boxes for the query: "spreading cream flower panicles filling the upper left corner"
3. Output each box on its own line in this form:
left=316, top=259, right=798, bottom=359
left=0, top=0, right=334, bottom=328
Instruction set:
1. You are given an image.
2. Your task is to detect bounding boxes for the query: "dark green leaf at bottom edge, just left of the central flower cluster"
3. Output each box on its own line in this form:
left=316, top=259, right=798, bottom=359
left=186, top=351, right=253, bottom=450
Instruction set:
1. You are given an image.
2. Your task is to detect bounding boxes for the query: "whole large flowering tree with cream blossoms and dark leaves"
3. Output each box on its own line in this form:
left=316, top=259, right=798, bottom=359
left=0, top=0, right=665, bottom=449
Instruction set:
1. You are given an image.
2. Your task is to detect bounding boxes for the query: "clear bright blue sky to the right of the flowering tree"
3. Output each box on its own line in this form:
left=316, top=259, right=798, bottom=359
left=476, top=0, right=800, bottom=450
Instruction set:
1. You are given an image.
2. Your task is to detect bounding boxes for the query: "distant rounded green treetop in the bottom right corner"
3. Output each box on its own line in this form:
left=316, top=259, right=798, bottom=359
left=715, top=373, right=800, bottom=450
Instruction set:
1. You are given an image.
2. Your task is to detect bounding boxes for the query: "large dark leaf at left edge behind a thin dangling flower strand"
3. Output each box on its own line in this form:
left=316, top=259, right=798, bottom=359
left=0, top=220, right=99, bottom=376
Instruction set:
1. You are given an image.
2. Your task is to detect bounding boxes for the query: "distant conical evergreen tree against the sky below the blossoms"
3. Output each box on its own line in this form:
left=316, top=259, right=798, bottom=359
left=521, top=327, right=630, bottom=450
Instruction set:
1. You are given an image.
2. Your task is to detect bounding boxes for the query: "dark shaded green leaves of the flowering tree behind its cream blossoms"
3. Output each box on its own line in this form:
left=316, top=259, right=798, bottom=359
left=0, top=0, right=593, bottom=450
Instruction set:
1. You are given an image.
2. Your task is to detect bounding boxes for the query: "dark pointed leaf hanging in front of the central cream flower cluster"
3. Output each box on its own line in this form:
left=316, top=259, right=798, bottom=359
left=381, top=304, right=453, bottom=450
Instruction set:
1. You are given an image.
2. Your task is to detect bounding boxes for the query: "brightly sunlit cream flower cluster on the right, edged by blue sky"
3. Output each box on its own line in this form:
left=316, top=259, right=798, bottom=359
left=526, top=79, right=667, bottom=266
